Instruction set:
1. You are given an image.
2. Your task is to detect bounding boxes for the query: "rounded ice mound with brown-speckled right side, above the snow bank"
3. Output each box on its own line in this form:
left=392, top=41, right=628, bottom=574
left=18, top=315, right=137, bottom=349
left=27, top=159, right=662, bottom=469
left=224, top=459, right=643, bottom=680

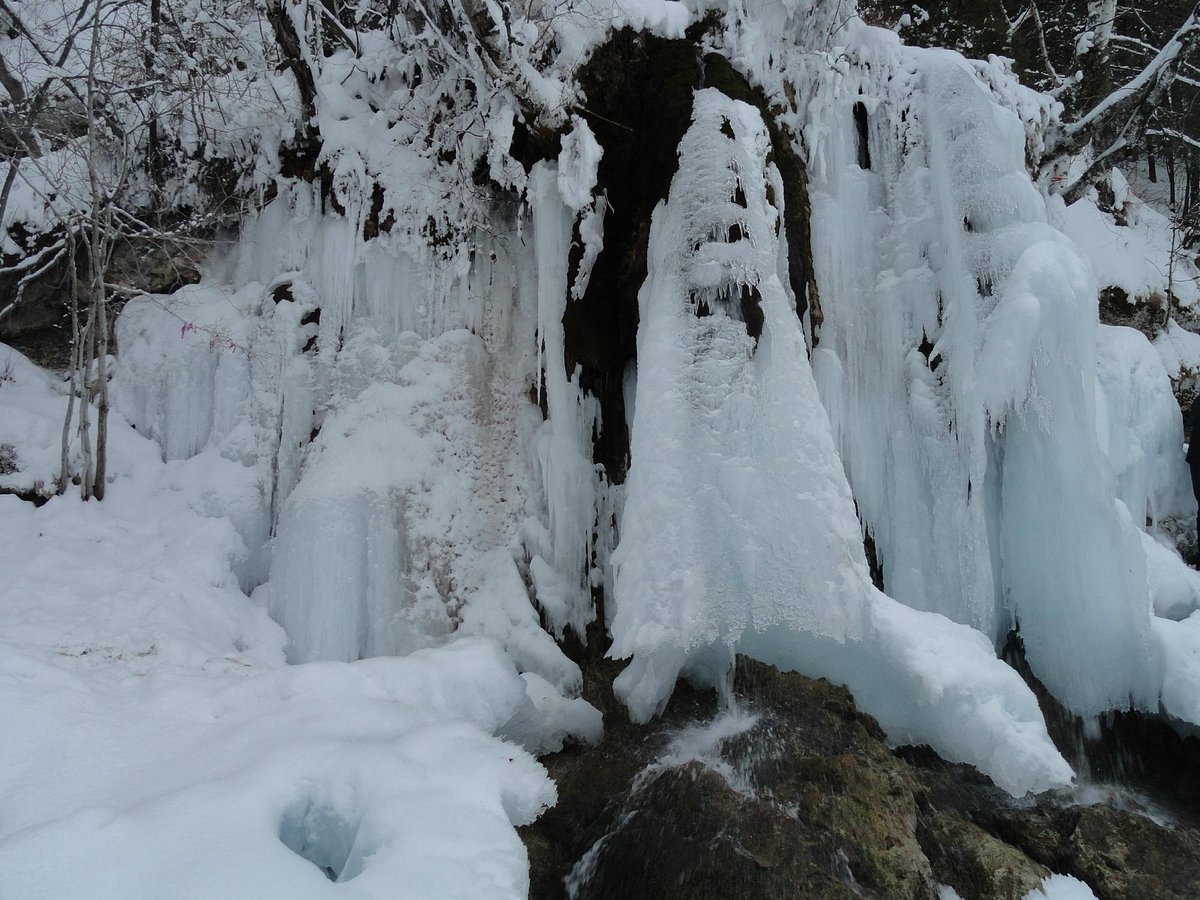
left=262, top=331, right=482, bottom=661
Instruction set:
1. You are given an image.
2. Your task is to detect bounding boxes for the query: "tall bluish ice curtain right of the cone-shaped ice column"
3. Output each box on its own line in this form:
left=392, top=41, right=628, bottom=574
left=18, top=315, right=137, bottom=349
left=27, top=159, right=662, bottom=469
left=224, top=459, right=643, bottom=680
left=808, top=26, right=1172, bottom=714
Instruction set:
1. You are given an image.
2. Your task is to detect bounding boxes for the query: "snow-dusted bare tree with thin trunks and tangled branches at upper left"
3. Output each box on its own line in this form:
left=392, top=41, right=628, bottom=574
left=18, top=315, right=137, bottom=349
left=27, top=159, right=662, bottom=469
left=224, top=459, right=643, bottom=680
left=0, top=0, right=278, bottom=499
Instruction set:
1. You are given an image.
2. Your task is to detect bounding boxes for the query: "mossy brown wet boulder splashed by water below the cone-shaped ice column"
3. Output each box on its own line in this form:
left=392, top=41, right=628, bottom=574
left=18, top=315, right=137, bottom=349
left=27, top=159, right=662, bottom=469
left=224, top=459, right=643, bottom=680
left=526, top=661, right=936, bottom=900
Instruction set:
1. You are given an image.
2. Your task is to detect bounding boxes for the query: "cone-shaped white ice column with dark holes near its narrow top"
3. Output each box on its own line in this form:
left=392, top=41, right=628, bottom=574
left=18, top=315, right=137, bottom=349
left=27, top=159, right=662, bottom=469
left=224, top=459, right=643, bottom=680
left=610, top=90, right=1072, bottom=793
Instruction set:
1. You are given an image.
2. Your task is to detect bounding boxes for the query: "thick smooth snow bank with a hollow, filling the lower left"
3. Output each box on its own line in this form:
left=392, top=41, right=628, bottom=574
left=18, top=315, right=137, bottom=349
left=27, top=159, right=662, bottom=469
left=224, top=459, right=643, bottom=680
left=0, top=376, right=573, bottom=899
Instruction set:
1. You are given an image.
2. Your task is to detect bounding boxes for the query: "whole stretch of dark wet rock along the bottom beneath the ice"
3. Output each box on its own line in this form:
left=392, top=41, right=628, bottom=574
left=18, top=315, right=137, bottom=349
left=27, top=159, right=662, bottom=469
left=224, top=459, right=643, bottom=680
left=523, top=660, right=1200, bottom=900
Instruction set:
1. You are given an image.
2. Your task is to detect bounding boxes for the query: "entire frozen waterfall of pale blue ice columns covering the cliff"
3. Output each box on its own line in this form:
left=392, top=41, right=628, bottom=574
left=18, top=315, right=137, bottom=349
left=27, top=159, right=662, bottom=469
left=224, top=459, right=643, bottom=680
left=105, top=7, right=1196, bottom=791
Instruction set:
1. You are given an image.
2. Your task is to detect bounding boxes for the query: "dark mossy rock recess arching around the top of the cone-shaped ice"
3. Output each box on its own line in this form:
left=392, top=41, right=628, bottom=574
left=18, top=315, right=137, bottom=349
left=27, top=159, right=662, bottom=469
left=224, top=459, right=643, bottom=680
left=556, top=30, right=820, bottom=484
